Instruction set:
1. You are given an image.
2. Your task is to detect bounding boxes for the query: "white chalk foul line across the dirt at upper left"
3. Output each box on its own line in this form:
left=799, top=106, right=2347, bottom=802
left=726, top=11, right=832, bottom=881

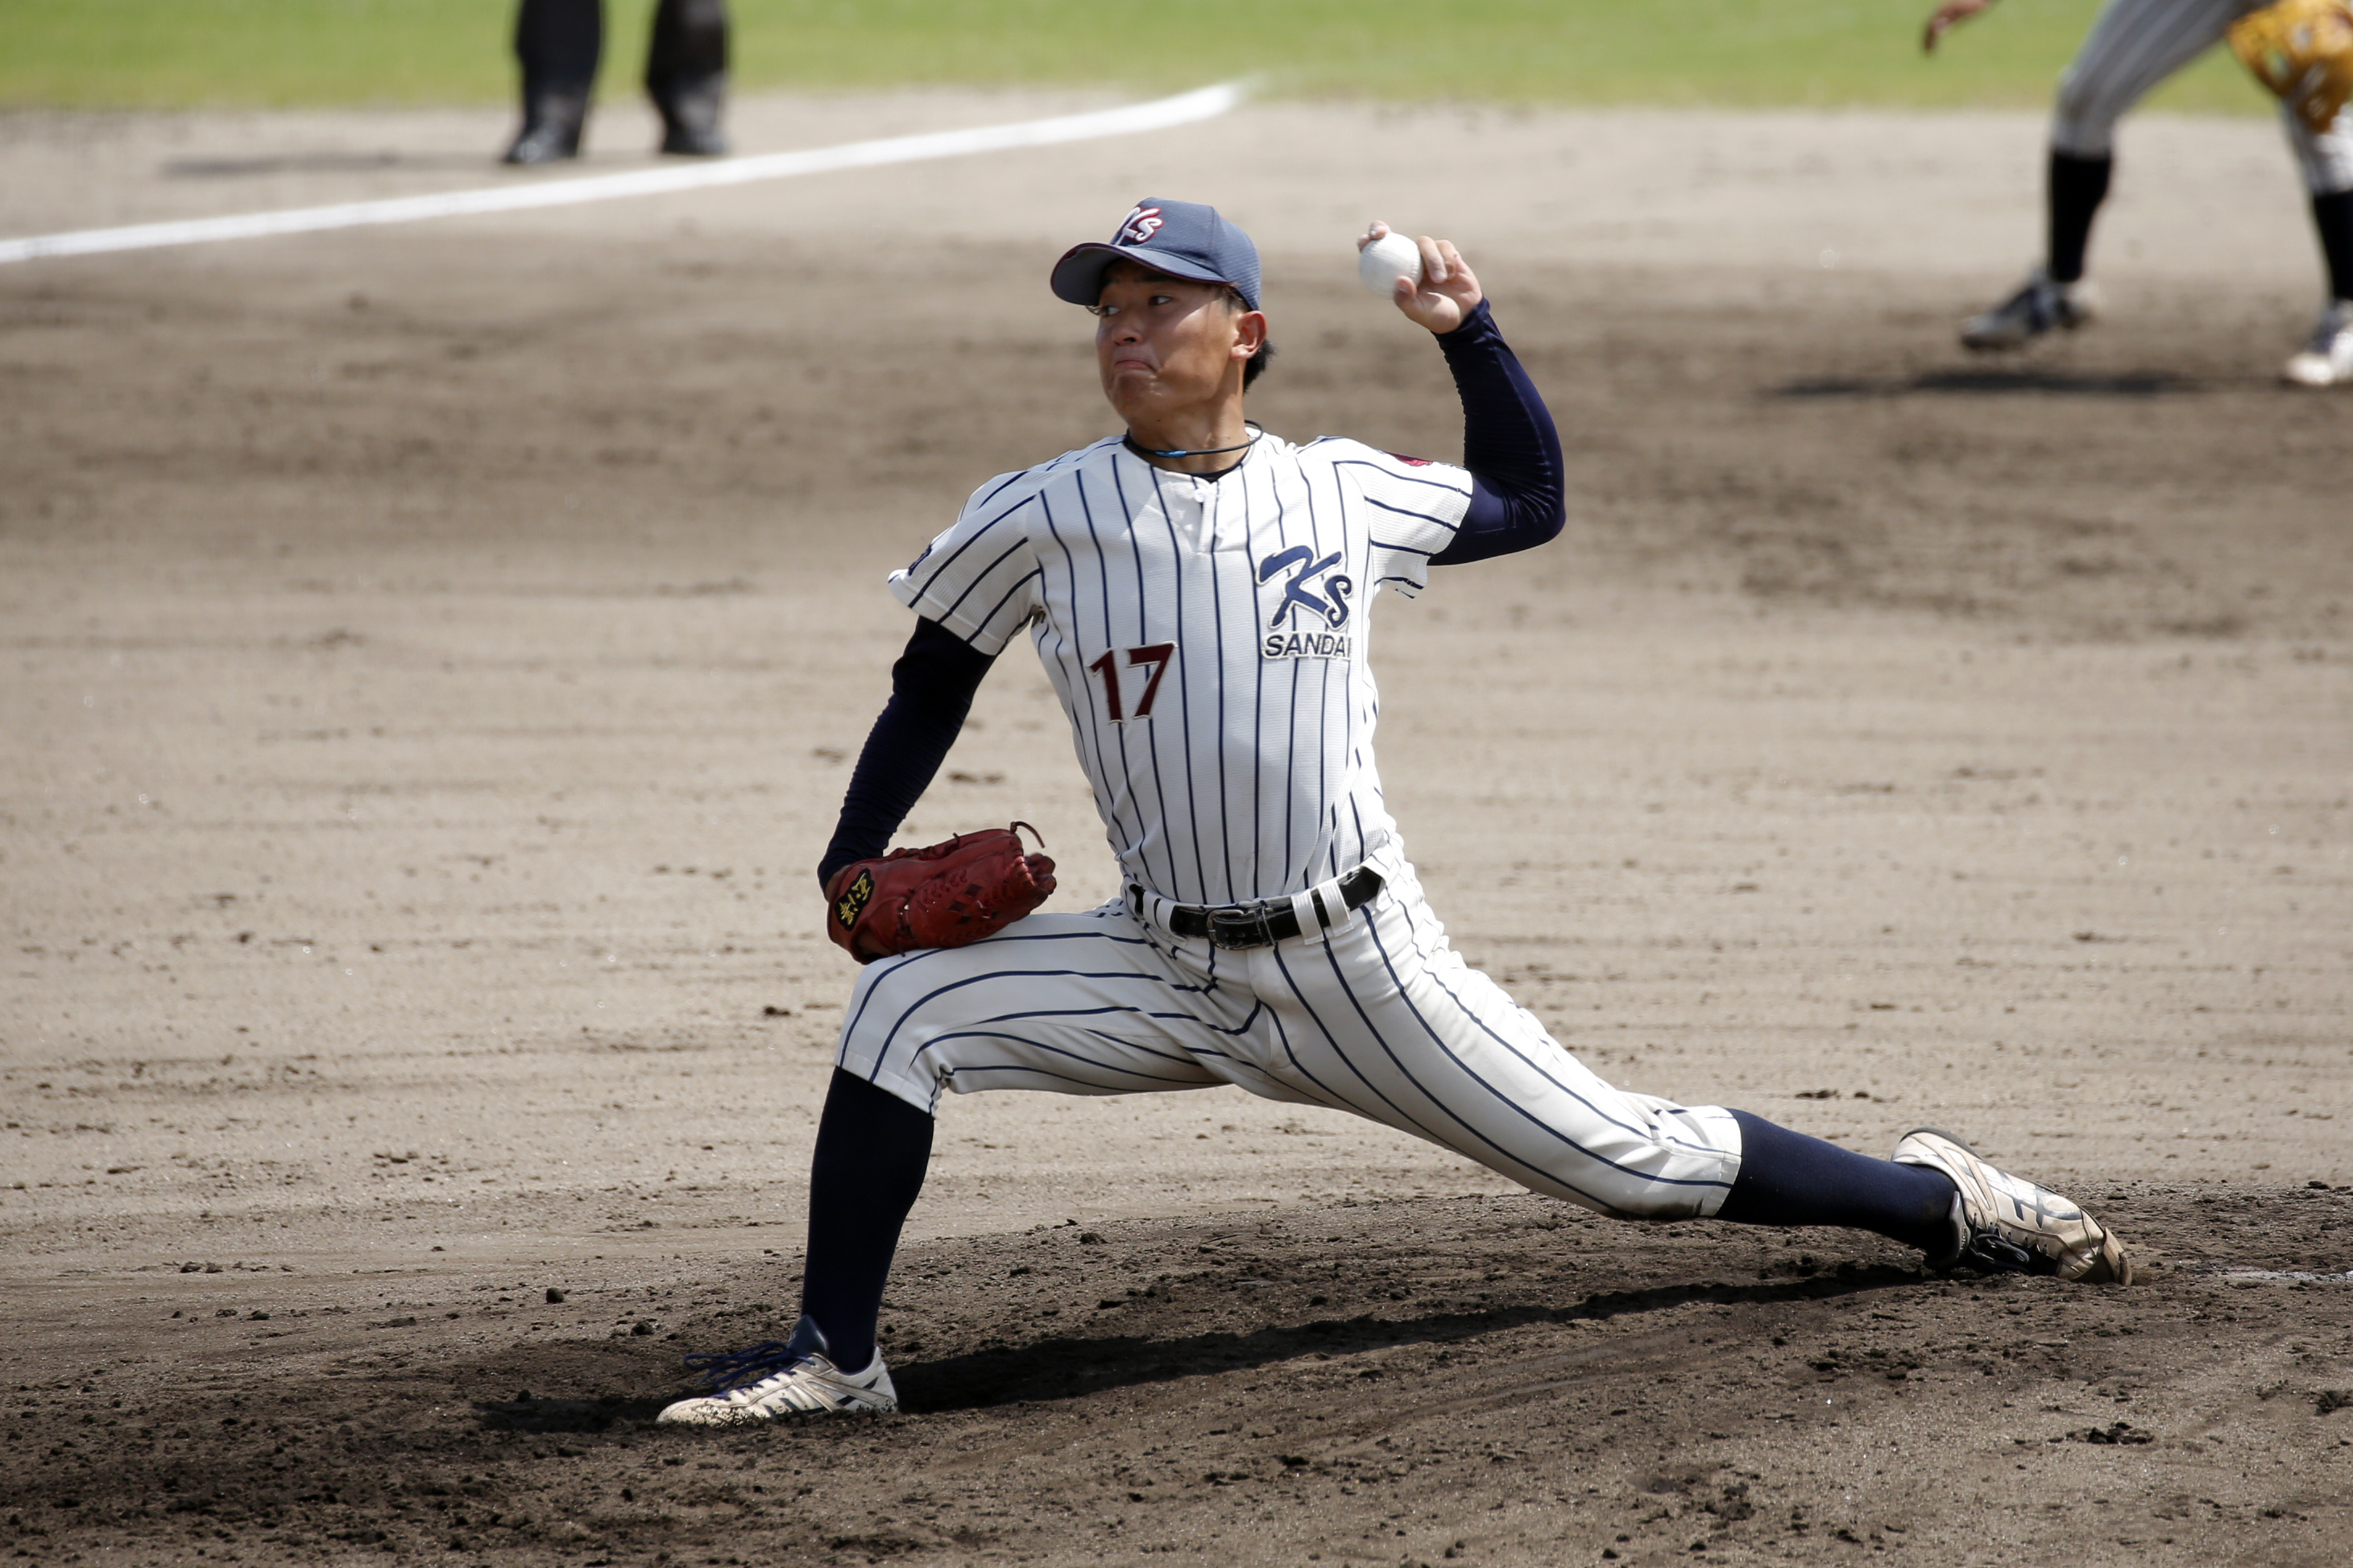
left=0, top=82, right=1242, bottom=266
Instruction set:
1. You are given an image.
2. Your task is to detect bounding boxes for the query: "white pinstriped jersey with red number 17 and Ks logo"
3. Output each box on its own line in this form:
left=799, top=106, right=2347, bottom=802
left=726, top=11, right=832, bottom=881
left=889, top=435, right=1471, bottom=905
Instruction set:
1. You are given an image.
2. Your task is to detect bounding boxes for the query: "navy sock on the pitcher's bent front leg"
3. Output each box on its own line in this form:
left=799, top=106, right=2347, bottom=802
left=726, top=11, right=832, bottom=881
left=800, top=1067, right=932, bottom=1373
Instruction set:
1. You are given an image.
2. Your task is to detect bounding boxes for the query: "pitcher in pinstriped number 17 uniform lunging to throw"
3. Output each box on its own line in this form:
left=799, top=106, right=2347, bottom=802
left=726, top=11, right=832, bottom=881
left=661, top=197, right=2130, bottom=1425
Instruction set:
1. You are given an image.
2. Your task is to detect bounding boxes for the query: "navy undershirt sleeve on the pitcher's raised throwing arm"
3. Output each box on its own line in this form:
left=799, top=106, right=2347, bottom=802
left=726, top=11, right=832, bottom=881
left=1431, top=301, right=1567, bottom=566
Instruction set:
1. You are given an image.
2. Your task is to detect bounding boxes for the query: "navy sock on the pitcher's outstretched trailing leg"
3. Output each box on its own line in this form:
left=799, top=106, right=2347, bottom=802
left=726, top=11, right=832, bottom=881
left=1715, top=1110, right=1953, bottom=1258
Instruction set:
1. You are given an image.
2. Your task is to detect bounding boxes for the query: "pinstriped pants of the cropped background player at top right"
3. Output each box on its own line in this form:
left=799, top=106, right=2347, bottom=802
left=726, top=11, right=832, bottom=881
left=2052, top=0, right=2353, bottom=195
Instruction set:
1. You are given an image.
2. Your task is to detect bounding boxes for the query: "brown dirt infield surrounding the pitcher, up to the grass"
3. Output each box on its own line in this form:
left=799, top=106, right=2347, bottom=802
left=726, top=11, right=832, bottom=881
left=0, top=94, right=2353, bottom=1566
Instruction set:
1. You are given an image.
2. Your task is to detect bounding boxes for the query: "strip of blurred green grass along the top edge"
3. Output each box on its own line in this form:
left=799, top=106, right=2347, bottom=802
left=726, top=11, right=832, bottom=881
left=0, top=0, right=2268, bottom=113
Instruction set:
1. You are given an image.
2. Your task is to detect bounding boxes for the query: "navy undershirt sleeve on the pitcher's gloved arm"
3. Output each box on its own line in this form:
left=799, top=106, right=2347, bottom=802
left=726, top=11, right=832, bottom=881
left=817, top=621, right=996, bottom=884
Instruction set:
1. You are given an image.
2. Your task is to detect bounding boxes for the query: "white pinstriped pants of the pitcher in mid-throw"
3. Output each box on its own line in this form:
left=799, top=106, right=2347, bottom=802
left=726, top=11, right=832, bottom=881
left=835, top=867, right=1742, bottom=1220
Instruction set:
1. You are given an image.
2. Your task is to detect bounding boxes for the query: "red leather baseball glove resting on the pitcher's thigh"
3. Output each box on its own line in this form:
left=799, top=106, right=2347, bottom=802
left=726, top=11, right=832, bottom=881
left=826, top=823, right=1054, bottom=964
